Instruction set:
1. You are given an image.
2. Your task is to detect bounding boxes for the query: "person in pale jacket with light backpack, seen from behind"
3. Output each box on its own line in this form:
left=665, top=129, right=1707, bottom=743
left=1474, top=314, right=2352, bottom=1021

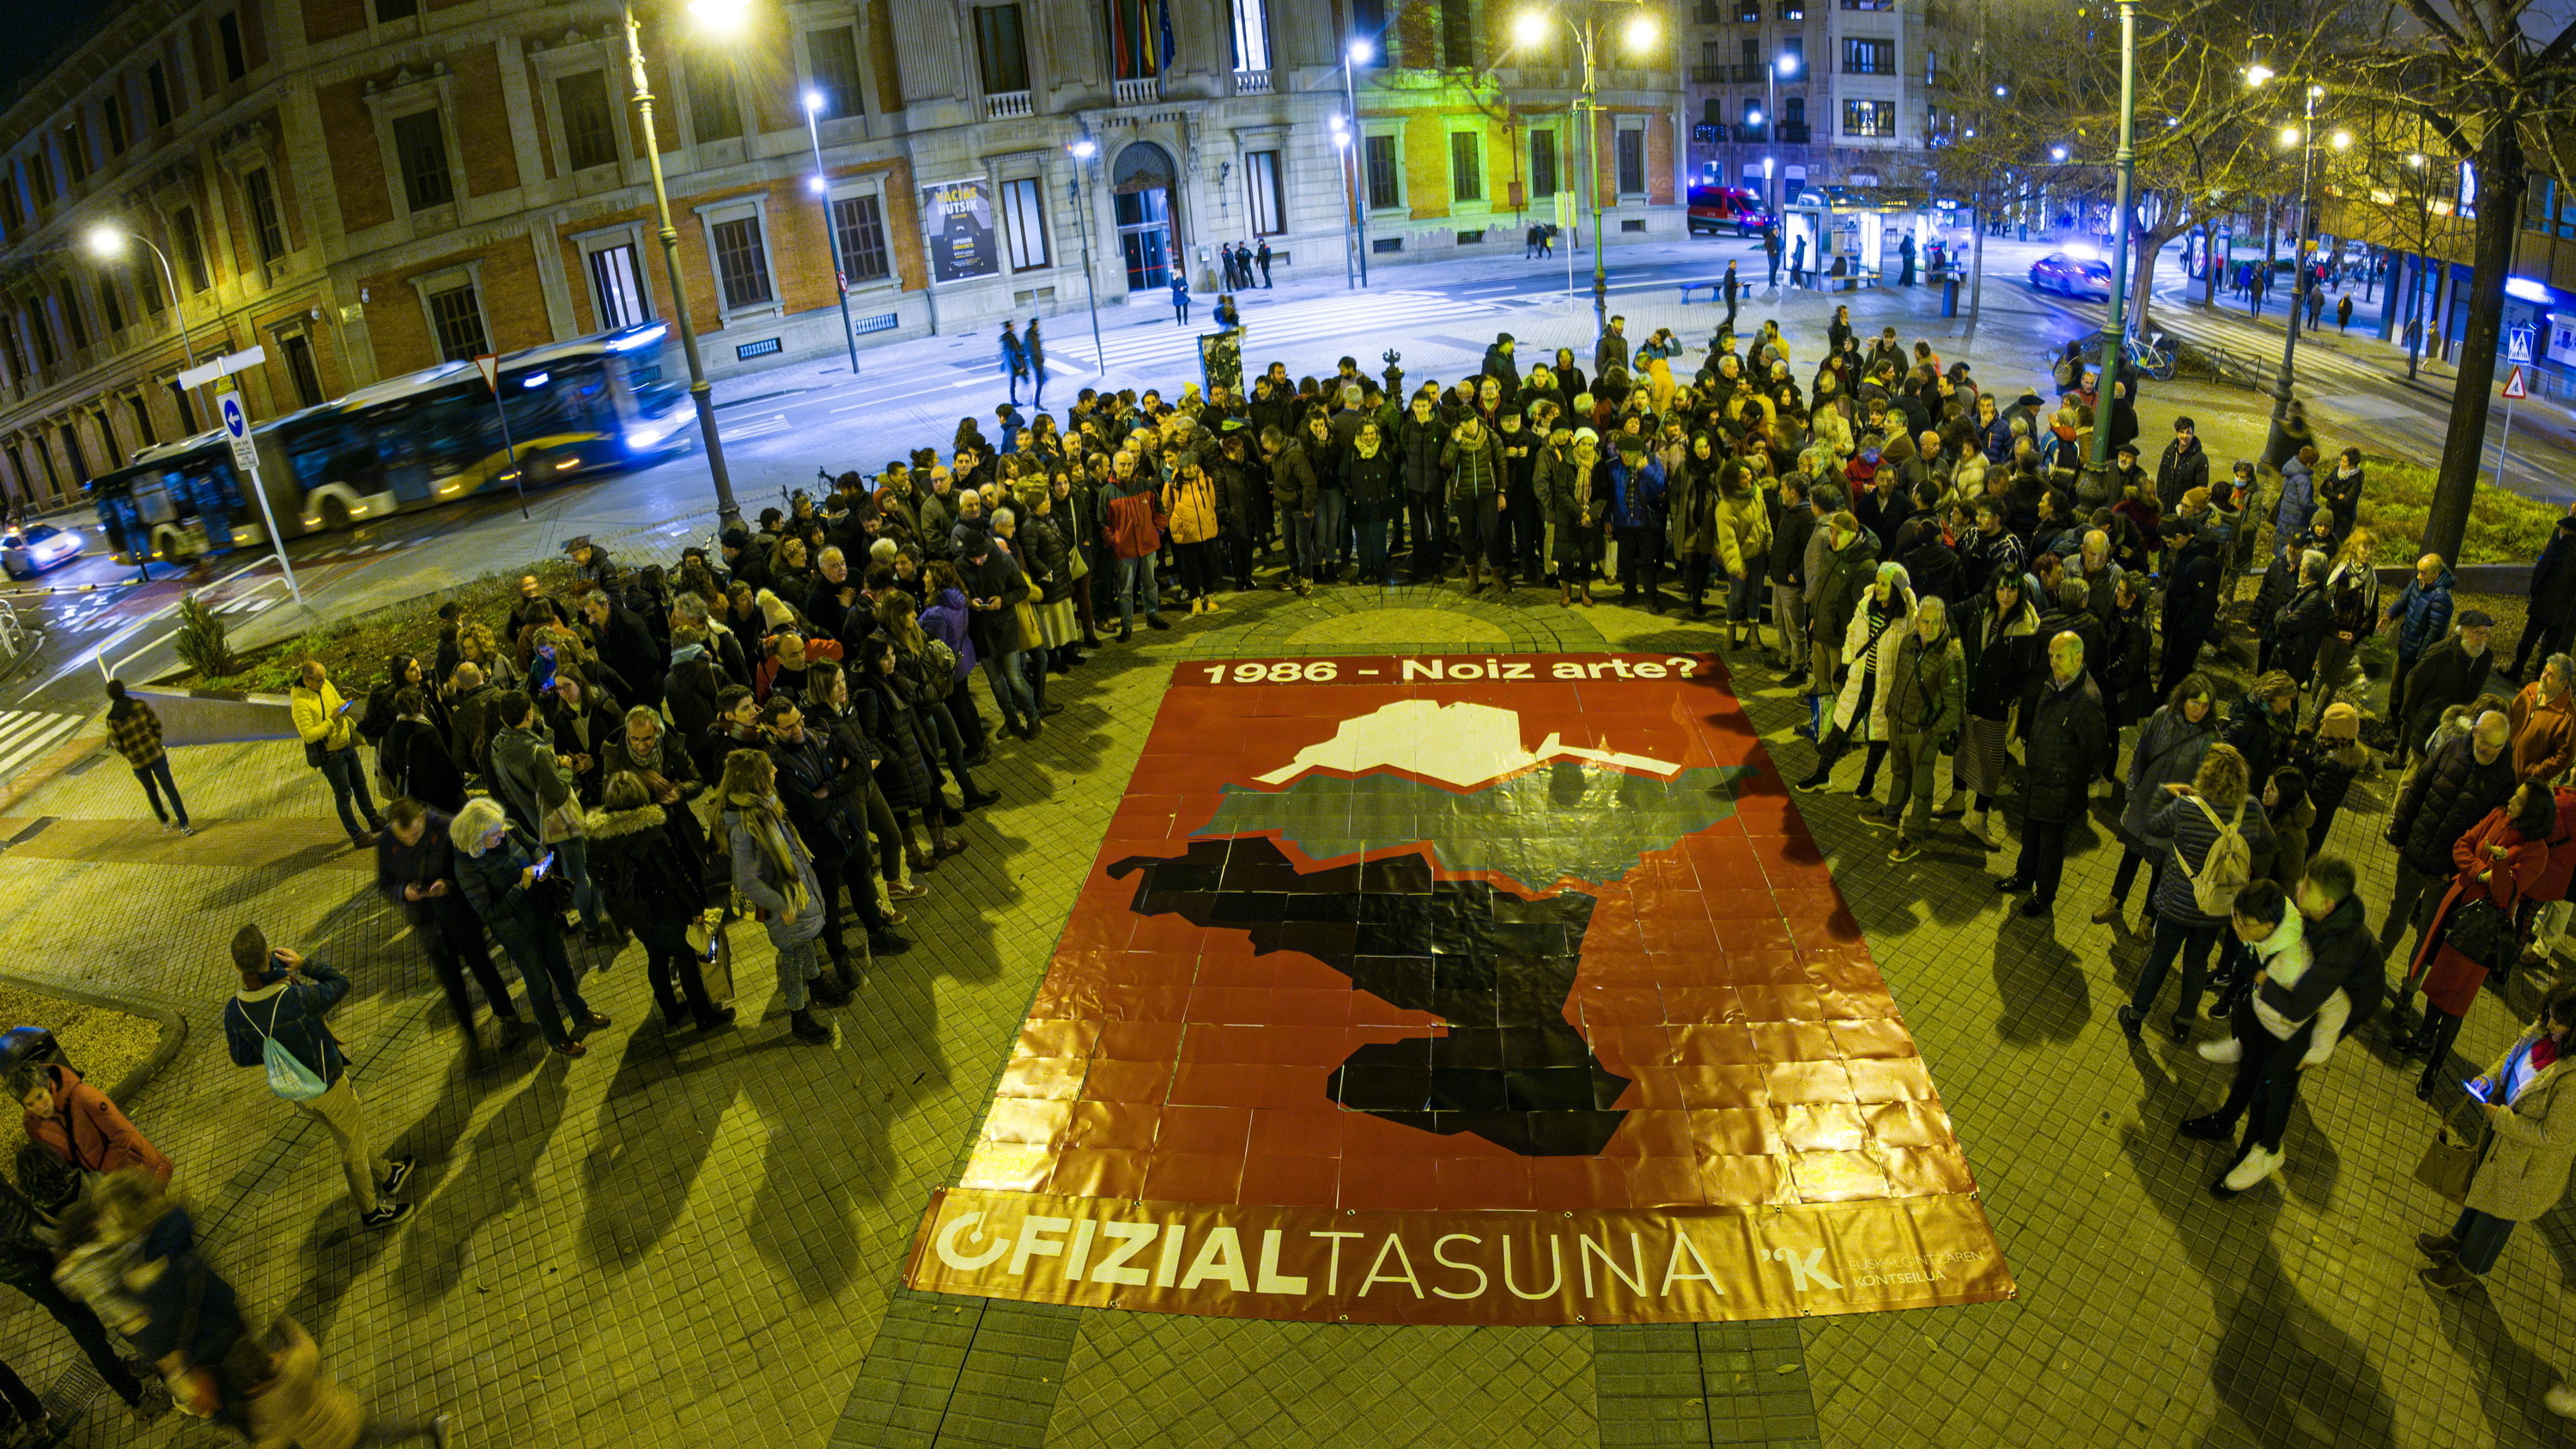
left=2120, top=746, right=2275, bottom=1042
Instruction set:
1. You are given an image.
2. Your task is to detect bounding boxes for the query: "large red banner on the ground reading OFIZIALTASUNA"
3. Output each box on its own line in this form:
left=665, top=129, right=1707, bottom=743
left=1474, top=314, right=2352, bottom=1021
left=907, top=654, right=2012, bottom=1323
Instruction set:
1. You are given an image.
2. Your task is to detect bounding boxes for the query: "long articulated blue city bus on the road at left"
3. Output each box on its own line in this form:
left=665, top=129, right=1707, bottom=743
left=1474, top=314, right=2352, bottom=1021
left=82, top=322, right=693, bottom=562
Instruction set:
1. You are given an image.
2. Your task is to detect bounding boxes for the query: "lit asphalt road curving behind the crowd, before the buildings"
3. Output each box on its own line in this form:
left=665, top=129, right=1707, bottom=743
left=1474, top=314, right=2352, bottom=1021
left=0, top=237, right=2576, bottom=732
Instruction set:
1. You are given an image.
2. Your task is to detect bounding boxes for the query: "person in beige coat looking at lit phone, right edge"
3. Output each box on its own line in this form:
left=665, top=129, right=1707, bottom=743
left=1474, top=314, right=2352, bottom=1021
left=2416, top=983, right=2576, bottom=1292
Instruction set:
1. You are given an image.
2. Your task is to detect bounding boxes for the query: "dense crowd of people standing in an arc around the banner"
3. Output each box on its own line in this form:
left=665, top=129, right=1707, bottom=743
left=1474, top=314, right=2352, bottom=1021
left=0, top=289, right=2576, bottom=1431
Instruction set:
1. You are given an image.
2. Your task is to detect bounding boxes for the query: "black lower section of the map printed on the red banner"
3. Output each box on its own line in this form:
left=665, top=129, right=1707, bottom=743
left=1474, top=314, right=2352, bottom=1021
left=1110, top=836, right=1628, bottom=1158
